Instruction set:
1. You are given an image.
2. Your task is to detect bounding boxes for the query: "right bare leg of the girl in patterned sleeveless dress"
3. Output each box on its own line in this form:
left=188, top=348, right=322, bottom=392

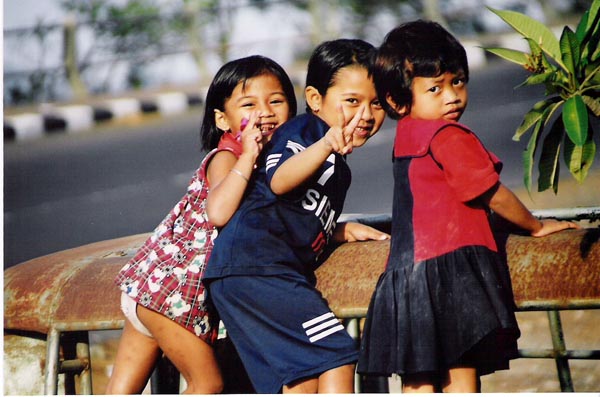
left=137, top=306, right=223, bottom=394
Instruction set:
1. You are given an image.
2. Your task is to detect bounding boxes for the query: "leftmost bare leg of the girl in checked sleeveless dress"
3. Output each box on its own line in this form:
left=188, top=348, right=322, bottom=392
left=106, top=320, right=161, bottom=394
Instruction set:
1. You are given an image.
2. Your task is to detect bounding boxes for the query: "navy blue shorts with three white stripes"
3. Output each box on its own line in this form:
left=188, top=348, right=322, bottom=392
left=208, top=273, right=358, bottom=394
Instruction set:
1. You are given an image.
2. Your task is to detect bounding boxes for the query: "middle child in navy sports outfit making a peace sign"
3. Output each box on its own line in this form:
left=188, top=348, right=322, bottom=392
left=205, top=39, right=389, bottom=393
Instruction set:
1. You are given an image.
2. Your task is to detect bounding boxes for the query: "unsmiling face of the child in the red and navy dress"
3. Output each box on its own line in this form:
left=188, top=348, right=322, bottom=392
left=409, top=71, right=469, bottom=121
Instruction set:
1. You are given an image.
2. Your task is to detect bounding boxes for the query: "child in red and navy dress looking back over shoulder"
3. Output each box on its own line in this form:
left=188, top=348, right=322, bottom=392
left=358, top=21, right=576, bottom=392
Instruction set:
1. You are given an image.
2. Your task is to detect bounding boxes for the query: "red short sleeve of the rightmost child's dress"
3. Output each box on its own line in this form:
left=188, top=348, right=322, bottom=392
left=430, top=125, right=502, bottom=202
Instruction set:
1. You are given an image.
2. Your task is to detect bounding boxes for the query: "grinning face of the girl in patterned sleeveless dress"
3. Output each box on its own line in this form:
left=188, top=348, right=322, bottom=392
left=215, top=74, right=290, bottom=141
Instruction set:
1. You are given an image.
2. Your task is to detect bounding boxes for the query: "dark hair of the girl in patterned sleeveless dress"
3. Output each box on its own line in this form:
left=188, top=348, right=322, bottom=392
left=200, top=55, right=298, bottom=151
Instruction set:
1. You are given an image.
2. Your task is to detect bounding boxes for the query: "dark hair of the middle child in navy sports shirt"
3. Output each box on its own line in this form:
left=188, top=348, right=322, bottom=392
left=306, top=39, right=375, bottom=113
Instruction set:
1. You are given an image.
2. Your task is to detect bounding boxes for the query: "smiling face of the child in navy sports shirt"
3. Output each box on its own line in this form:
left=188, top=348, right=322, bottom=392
left=307, top=65, right=385, bottom=147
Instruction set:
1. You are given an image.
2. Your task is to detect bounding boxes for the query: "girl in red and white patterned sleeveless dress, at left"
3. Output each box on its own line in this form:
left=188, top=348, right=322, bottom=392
left=107, top=56, right=296, bottom=394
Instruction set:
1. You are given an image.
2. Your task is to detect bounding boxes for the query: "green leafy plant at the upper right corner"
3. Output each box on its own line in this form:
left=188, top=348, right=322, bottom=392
left=485, top=0, right=600, bottom=194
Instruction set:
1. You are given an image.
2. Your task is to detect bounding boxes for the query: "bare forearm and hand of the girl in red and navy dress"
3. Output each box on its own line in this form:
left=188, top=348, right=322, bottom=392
left=482, top=183, right=579, bottom=237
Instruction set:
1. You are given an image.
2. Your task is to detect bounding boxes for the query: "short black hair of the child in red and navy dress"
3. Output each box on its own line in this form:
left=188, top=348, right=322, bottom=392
left=371, top=20, right=469, bottom=119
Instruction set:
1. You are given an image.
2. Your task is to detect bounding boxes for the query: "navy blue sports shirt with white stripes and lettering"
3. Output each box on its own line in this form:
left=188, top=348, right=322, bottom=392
left=204, top=114, right=351, bottom=279
